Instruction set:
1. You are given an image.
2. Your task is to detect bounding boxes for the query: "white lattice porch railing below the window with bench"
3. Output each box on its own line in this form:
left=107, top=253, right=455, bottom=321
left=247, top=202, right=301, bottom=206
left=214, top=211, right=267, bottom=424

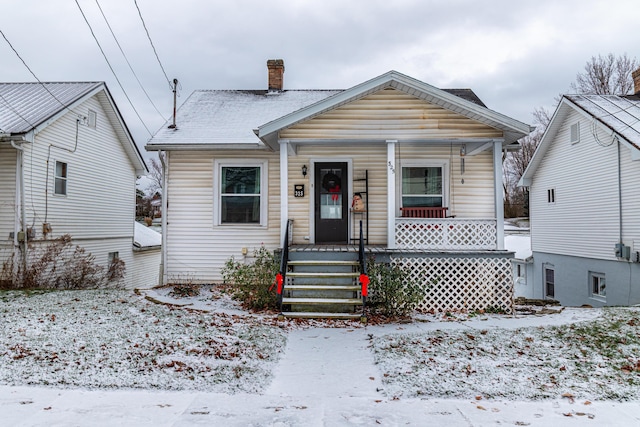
left=395, top=218, right=498, bottom=250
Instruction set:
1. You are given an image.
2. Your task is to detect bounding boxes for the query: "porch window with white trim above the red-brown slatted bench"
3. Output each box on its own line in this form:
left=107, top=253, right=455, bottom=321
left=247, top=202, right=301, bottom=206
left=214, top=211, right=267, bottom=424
left=401, top=164, right=447, bottom=207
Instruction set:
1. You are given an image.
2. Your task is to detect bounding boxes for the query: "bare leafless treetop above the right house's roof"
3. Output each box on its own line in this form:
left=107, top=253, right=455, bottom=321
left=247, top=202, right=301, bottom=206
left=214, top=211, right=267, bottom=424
left=571, top=53, right=638, bottom=95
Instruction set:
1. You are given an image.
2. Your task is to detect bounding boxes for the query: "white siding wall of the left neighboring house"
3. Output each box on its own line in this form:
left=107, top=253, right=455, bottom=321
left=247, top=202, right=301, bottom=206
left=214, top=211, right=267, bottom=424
left=12, top=96, right=142, bottom=287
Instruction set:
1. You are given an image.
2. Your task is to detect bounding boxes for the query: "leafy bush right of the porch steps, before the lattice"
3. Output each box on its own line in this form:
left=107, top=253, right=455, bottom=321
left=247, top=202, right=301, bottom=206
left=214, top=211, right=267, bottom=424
left=367, top=258, right=423, bottom=317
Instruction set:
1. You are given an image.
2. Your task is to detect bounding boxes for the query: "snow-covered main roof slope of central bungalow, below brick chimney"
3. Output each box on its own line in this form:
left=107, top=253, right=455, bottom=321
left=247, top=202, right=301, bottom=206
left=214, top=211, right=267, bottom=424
left=147, top=90, right=342, bottom=150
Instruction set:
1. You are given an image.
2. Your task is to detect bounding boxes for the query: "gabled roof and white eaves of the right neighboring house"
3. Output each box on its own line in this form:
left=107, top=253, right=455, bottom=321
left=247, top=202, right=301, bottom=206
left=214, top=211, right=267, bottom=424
left=518, top=95, right=640, bottom=186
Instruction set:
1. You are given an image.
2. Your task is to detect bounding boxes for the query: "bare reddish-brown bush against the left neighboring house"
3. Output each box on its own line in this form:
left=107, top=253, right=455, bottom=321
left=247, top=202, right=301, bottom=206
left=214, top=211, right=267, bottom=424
left=0, top=234, right=125, bottom=289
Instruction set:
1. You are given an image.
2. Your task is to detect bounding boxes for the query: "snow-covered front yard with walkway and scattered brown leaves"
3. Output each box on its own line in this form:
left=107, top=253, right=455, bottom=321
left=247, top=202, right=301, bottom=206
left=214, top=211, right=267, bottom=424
left=0, top=289, right=640, bottom=426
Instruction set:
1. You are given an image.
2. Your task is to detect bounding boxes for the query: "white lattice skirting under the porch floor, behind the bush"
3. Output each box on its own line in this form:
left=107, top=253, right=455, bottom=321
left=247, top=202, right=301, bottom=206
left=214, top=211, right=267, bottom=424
left=391, top=254, right=513, bottom=314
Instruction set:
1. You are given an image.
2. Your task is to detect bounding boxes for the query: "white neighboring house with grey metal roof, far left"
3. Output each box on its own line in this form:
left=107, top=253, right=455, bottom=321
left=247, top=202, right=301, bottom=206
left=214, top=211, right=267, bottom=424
left=0, top=82, right=160, bottom=287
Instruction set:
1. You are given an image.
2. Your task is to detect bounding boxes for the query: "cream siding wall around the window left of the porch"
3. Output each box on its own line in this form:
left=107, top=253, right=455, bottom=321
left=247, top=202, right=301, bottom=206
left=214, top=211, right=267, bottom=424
left=163, top=151, right=278, bottom=282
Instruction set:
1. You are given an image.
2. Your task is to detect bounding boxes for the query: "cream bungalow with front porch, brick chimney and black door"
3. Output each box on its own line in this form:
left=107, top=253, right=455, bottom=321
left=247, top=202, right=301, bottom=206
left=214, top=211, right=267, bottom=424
left=146, top=60, right=530, bottom=318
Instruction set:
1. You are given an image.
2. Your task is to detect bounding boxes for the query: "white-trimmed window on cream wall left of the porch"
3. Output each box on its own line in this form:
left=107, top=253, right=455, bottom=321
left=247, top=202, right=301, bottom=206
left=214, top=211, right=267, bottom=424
left=214, top=161, right=267, bottom=225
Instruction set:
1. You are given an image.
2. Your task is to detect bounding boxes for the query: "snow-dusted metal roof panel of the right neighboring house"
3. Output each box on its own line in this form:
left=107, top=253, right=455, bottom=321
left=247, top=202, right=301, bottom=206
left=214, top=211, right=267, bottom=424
left=565, top=95, right=640, bottom=150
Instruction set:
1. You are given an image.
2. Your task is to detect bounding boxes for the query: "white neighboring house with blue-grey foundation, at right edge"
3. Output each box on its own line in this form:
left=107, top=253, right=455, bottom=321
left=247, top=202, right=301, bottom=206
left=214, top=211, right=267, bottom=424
left=520, top=70, right=640, bottom=306
